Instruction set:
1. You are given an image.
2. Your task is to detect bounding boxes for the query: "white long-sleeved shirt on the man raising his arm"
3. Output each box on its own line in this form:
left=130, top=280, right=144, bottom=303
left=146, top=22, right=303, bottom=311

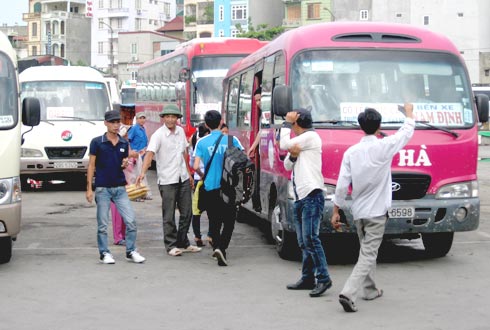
left=333, top=118, right=415, bottom=220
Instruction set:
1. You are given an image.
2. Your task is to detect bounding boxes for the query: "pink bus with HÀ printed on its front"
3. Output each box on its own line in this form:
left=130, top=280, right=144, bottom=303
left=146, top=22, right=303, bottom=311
left=223, top=22, right=488, bottom=258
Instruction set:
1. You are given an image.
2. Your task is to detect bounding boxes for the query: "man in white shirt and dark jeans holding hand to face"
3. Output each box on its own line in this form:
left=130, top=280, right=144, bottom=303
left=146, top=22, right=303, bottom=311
left=280, top=109, right=332, bottom=297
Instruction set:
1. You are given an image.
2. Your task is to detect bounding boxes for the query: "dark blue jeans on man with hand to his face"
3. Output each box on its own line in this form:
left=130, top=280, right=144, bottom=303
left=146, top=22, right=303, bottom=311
left=293, top=190, right=330, bottom=283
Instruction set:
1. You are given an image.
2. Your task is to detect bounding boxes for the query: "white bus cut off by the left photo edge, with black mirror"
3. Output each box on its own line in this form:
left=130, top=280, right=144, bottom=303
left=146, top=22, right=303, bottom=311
left=0, top=32, right=39, bottom=264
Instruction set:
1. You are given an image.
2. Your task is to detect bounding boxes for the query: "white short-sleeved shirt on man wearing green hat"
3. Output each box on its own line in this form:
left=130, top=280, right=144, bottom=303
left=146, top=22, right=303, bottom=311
left=147, top=124, right=189, bottom=185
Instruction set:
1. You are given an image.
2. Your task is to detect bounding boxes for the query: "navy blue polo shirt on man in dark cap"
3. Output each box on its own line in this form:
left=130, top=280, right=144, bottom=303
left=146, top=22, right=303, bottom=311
left=90, top=134, right=129, bottom=187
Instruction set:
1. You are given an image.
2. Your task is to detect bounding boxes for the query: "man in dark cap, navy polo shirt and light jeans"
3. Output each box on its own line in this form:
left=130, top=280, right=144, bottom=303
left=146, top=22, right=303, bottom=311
left=86, top=111, right=145, bottom=264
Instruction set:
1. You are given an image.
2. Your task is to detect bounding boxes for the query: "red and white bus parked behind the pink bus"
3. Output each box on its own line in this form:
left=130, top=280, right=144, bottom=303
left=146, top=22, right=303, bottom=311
left=136, top=38, right=266, bottom=136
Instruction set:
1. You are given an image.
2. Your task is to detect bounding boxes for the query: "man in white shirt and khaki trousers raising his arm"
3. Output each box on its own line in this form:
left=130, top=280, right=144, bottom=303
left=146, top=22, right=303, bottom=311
left=331, top=104, right=415, bottom=312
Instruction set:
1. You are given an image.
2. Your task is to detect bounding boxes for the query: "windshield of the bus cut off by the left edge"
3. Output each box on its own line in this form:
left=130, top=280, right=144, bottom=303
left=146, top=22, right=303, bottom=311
left=0, top=52, right=18, bottom=130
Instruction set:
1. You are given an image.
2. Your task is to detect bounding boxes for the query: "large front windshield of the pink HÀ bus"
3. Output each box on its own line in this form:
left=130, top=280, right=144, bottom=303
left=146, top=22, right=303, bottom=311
left=290, top=49, right=475, bottom=128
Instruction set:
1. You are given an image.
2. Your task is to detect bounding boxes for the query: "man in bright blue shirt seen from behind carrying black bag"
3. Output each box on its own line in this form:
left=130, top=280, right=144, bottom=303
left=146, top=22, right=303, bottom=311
left=193, top=110, right=243, bottom=266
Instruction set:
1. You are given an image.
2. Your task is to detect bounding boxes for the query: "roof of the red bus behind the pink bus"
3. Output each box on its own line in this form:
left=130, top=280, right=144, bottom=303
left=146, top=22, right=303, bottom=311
left=140, top=38, right=267, bottom=69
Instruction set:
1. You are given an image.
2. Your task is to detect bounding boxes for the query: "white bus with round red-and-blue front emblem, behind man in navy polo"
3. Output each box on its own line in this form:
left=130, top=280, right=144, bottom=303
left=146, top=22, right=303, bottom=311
left=19, top=66, right=112, bottom=187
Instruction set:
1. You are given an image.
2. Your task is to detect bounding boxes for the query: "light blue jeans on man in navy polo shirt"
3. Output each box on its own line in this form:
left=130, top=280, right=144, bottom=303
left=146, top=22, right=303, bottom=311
left=95, top=186, right=136, bottom=254
